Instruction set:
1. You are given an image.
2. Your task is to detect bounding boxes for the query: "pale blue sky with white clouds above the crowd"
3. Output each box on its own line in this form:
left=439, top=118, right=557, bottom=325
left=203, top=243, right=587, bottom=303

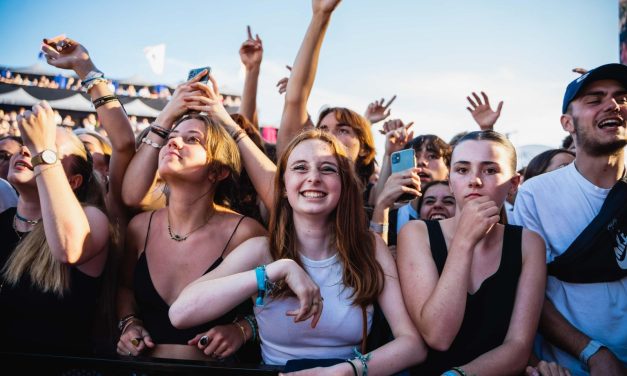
left=0, top=0, right=618, bottom=162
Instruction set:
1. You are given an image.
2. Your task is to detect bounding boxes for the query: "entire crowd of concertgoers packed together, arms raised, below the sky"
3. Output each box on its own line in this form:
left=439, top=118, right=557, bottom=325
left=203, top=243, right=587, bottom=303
left=0, top=0, right=627, bottom=376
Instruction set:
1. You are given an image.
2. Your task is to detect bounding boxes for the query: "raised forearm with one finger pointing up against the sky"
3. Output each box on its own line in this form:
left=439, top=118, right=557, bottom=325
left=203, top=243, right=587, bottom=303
left=239, top=26, right=263, bottom=129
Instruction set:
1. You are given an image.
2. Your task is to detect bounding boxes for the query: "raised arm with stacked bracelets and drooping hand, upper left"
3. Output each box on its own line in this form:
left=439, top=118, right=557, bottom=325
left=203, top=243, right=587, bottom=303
left=42, top=37, right=135, bottom=227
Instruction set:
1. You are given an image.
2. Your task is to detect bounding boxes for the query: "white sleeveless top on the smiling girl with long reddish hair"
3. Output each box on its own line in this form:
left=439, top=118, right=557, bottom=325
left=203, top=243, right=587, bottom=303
left=254, top=253, right=373, bottom=365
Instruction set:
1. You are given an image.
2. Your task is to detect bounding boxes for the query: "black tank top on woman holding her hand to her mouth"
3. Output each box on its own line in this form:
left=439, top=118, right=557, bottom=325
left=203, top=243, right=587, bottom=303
left=412, top=221, right=522, bottom=375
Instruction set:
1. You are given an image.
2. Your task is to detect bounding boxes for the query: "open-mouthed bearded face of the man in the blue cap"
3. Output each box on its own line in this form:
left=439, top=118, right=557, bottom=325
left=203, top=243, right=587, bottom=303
left=565, top=80, right=627, bottom=156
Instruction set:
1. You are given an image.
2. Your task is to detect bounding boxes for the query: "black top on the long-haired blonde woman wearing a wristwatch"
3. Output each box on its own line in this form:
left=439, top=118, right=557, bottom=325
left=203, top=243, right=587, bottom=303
left=0, top=208, right=102, bottom=355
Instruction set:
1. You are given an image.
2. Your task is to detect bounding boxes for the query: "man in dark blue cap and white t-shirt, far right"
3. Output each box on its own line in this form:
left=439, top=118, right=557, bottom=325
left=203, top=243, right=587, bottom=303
left=512, top=64, right=627, bottom=375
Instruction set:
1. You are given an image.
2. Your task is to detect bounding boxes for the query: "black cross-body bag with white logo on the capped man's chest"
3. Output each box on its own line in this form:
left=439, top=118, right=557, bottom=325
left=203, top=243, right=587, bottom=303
left=548, top=176, right=627, bottom=283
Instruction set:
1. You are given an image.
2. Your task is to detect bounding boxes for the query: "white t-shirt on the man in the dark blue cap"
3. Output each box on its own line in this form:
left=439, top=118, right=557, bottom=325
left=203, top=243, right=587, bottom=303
left=512, top=163, right=627, bottom=376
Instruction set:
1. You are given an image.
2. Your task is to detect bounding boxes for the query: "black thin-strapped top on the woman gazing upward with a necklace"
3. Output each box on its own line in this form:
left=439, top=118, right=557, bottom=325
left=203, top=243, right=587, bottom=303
left=133, top=212, right=252, bottom=345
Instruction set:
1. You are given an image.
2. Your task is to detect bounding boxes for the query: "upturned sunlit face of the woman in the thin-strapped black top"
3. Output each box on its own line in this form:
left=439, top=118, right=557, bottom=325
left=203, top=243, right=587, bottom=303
left=159, top=119, right=209, bottom=180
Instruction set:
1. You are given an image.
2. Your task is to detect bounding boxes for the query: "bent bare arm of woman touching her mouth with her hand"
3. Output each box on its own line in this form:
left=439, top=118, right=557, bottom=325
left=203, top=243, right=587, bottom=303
left=396, top=197, right=499, bottom=351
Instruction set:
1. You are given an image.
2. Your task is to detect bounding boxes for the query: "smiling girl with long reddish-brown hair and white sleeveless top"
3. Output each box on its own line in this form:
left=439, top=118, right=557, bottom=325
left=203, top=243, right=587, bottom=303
left=170, top=130, right=426, bottom=375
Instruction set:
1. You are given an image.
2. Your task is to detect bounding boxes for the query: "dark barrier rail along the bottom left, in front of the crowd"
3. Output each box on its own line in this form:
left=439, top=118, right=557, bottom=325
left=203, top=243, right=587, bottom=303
left=0, top=353, right=282, bottom=376
